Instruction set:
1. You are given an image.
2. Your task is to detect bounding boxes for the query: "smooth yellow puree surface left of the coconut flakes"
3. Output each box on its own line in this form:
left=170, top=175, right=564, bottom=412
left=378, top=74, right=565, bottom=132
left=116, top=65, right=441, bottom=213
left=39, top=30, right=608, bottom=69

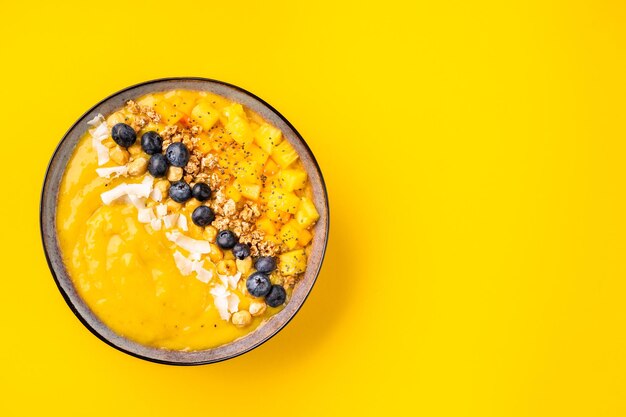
left=57, top=135, right=266, bottom=350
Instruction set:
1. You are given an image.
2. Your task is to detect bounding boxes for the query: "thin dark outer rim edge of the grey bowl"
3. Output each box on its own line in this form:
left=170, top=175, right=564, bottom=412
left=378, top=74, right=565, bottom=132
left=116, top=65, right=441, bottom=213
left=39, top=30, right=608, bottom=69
left=39, top=77, right=330, bottom=366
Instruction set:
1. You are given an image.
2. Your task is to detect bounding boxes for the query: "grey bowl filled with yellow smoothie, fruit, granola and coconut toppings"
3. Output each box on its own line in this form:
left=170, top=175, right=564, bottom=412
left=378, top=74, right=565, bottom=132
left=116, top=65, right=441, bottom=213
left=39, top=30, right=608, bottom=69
left=41, top=78, right=329, bottom=365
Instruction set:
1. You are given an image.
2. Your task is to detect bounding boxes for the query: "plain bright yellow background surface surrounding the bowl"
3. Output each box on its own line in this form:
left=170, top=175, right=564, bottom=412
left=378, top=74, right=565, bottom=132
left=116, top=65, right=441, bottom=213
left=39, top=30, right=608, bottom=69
left=0, top=0, right=626, bottom=416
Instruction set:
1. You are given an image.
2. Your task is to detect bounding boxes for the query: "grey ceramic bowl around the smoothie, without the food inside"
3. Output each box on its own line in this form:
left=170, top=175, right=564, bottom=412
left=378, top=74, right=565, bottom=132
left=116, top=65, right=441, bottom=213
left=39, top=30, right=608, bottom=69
left=40, top=77, right=329, bottom=365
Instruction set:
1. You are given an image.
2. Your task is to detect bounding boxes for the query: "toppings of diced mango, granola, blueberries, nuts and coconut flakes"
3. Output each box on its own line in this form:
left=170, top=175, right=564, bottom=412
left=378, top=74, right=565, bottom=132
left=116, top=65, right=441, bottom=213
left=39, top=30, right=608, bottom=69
left=58, top=90, right=319, bottom=343
